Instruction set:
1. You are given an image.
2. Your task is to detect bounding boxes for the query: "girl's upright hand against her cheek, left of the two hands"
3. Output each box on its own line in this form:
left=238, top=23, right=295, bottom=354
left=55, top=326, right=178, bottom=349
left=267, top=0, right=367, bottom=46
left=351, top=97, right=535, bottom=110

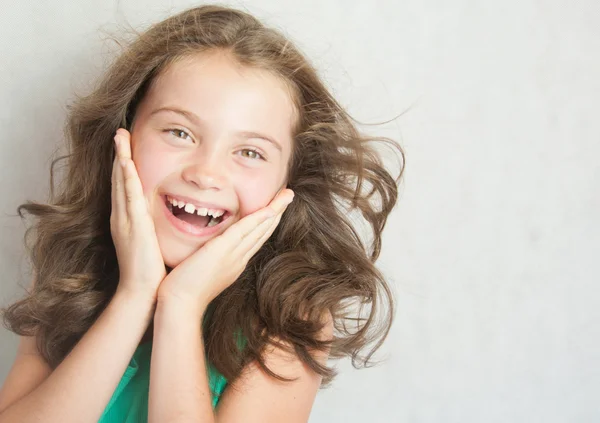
left=110, top=128, right=167, bottom=301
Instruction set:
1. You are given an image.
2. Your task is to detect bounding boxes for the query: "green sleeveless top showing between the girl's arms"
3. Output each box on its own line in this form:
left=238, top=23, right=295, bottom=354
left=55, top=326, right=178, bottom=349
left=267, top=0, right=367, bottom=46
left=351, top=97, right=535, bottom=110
left=98, top=342, right=227, bottom=423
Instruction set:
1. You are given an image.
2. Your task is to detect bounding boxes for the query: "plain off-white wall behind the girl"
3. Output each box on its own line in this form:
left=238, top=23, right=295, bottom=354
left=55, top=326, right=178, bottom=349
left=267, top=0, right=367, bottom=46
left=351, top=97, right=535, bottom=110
left=0, top=0, right=600, bottom=423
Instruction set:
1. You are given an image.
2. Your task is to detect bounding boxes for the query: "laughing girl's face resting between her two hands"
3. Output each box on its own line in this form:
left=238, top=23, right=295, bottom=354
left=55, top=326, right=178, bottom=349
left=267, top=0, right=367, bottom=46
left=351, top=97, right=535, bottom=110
left=131, top=52, right=294, bottom=268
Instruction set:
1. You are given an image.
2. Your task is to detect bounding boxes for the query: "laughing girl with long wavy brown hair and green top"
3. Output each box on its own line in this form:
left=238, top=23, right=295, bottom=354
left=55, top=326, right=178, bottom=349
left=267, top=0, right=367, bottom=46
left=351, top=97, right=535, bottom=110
left=0, top=6, right=404, bottom=423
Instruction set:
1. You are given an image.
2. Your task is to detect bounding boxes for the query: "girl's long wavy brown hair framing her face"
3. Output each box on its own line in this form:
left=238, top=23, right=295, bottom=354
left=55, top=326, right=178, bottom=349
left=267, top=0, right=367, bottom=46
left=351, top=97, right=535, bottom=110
left=2, top=5, right=404, bottom=386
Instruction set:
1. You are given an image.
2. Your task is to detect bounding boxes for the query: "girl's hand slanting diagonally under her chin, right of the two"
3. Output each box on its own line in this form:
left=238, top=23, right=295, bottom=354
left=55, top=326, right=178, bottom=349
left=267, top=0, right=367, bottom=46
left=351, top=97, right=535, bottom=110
left=157, top=189, right=294, bottom=312
